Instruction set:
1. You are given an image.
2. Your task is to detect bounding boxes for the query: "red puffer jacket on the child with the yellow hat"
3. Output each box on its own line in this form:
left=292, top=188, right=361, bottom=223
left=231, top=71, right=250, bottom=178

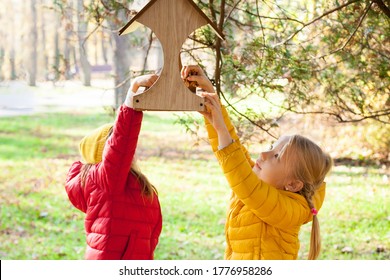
left=65, top=106, right=162, bottom=260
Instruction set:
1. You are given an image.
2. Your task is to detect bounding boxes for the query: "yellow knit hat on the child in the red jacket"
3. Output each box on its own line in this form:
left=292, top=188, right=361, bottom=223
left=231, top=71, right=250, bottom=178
left=79, top=124, right=113, bottom=164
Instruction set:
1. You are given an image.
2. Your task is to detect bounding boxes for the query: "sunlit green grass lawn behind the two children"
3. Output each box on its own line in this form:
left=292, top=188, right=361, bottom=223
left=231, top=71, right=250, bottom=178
left=0, top=111, right=390, bottom=260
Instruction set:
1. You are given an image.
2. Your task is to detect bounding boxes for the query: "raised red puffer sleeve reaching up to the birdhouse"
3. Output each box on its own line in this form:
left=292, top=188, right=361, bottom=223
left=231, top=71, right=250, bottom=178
left=97, top=105, right=143, bottom=193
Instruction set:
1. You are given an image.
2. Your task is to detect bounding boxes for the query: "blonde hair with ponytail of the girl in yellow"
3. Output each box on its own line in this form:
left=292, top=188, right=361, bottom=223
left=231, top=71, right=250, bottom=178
left=280, top=135, right=333, bottom=260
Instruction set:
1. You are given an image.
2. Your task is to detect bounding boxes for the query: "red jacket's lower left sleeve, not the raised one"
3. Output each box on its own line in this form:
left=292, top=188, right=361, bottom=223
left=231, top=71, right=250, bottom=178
left=65, top=161, right=87, bottom=213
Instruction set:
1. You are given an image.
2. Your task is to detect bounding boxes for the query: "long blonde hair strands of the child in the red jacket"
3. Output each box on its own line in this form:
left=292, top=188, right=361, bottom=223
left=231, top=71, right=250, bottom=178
left=80, top=127, right=158, bottom=199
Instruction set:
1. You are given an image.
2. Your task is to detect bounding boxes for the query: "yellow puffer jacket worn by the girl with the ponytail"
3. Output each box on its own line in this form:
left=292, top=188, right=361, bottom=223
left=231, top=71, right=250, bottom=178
left=205, top=107, right=325, bottom=260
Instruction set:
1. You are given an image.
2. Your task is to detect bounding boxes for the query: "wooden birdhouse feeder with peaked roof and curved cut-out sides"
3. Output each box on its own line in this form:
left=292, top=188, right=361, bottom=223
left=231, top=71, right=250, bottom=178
left=119, top=0, right=224, bottom=111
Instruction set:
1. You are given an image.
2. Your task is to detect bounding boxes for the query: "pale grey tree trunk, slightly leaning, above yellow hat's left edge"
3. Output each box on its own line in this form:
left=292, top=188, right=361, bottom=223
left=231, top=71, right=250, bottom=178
left=77, top=0, right=91, bottom=86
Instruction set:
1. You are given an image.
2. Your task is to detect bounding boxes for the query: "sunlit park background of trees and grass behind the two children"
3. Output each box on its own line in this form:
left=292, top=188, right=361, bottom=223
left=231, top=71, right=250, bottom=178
left=0, top=0, right=390, bottom=259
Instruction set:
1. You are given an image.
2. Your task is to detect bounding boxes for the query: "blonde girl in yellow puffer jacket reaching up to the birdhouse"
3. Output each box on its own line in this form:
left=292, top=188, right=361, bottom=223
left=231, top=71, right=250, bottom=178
left=181, top=66, right=332, bottom=260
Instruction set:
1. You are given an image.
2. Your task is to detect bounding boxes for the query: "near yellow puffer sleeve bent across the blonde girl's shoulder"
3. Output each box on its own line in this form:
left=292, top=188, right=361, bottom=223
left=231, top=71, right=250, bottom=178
left=215, top=142, right=311, bottom=229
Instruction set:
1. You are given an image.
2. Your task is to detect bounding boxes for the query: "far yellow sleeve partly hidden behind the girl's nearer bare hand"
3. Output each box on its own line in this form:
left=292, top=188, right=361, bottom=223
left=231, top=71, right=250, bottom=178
left=204, top=105, right=255, bottom=167
